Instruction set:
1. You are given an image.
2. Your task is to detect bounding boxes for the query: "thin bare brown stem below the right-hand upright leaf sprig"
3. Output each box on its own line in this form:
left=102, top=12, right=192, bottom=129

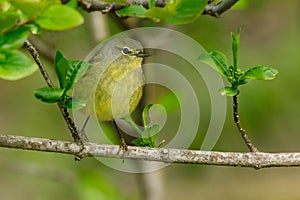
left=233, top=93, right=258, bottom=153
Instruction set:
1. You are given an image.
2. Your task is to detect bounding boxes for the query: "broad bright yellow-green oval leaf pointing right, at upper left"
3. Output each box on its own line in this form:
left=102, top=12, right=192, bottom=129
left=36, top=5, right=84, bottom=31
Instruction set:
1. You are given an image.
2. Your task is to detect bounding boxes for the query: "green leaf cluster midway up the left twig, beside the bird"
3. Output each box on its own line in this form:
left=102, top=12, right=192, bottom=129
left=34, top=51, right=91, bottom=109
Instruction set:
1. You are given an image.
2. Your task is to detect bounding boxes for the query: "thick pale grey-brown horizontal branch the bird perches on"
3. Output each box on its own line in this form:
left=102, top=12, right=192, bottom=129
left=0, top=134, right=300, bottom=169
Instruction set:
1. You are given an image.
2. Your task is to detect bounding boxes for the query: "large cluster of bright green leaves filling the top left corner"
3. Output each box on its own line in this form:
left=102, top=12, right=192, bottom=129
left=0, top=0, right=84, bottom=80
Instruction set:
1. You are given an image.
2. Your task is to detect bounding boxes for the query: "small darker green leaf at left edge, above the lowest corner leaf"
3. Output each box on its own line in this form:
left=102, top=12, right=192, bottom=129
left=0, top=27, right=29, bottom=49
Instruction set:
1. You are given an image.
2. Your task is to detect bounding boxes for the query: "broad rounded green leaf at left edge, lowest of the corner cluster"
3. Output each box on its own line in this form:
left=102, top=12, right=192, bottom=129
left=0, top=50, right=38, bottom=80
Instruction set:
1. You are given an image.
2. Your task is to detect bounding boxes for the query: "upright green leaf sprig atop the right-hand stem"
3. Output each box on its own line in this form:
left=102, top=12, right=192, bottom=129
left=199, top=29, right=278, bottom=96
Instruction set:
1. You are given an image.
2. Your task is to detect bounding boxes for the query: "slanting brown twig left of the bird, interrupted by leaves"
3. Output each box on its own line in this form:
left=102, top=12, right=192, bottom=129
left=25, top=40, right=83, bottom=146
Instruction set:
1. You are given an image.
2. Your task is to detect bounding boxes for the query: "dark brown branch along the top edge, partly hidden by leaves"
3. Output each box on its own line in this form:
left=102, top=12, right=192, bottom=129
left=78, top=0, right=238, bottom=17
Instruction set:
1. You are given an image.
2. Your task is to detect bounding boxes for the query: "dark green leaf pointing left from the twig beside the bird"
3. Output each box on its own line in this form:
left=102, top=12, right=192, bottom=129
left=34, top=87, right=64, bottom=103
